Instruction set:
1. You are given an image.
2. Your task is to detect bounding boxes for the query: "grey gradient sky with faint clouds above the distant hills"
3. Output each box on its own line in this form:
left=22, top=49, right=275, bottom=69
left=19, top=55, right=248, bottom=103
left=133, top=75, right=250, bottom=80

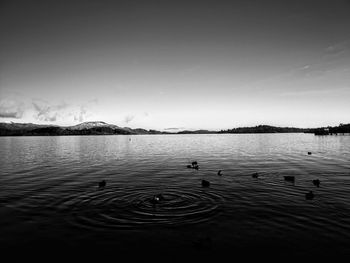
left=0, top=0, right=350, bottom=131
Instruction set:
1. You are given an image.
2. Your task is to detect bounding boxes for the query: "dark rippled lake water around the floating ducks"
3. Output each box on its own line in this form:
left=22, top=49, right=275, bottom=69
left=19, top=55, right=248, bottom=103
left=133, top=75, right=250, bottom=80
left=0, top=134, right=350, bottom=256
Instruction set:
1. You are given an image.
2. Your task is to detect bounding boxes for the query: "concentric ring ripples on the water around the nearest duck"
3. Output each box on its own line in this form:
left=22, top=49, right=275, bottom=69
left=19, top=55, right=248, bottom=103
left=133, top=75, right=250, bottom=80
left=60, top=186, right=223, bottom=231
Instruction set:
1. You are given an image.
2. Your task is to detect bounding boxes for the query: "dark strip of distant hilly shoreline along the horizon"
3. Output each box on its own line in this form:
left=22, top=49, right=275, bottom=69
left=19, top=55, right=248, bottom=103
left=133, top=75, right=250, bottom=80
left=0, top=121, right=350, bottom=136
